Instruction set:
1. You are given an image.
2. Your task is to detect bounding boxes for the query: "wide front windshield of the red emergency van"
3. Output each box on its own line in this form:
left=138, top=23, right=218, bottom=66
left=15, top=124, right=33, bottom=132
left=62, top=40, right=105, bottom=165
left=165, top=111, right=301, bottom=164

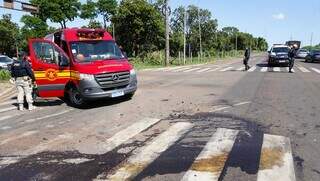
left=71, top=41, right=125, bottom=63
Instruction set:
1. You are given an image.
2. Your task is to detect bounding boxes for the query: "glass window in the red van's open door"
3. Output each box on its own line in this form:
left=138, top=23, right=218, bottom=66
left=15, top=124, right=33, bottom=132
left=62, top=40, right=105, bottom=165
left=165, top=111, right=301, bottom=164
left=33, top=42, right=66, bottom=65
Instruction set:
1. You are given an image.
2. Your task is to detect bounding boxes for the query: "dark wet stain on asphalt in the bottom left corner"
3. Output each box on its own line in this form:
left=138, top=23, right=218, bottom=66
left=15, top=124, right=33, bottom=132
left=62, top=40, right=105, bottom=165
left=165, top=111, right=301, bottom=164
left=0, top=126, right=164, bottom=181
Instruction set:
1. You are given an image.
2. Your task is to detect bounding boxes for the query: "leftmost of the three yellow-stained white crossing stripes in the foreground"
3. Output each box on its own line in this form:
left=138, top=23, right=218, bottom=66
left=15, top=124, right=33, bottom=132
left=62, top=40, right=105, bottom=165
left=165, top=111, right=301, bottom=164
left=102, top=122, right=192, bottom=180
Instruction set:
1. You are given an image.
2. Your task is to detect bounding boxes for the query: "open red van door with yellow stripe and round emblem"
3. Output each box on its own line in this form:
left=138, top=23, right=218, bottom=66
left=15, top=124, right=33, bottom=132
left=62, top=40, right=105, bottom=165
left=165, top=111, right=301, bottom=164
left=29, top=39, right=70, bottom=97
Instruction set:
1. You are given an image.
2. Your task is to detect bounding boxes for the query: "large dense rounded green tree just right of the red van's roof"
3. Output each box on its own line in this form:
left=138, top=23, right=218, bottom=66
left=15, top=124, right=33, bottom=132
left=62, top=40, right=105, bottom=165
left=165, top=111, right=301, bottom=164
left=112, top=0, right=165, bottom=55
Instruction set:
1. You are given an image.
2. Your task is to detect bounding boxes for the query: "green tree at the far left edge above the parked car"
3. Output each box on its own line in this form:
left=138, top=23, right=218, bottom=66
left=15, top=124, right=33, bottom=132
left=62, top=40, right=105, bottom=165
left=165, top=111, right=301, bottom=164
left=0, top=14, right=20, bottom=56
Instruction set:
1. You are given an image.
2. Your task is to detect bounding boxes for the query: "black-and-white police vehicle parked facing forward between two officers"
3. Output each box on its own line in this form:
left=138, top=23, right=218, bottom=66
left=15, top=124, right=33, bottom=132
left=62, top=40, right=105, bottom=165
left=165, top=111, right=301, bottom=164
left=268, top=45, right=289, bottom=66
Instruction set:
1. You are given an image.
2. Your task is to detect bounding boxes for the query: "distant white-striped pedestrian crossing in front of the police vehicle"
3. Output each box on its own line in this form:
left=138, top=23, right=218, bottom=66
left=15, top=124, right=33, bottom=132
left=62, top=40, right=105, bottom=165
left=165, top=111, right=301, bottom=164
left=152, top=65, right=320, bottom=74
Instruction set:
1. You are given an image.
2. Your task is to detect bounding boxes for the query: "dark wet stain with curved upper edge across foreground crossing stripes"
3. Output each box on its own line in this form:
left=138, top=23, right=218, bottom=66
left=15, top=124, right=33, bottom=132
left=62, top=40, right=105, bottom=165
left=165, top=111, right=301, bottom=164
left=134, top=112, right=268, bottom=180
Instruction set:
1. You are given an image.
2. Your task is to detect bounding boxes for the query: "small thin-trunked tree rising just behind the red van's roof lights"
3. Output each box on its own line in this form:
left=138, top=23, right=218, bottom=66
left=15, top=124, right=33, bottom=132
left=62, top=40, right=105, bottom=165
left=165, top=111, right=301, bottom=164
left=97, top=0, right=118, bottom=29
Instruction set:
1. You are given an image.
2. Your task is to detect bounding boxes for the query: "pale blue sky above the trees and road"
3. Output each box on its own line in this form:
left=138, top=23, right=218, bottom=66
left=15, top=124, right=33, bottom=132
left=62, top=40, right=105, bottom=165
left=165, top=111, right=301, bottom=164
left=0, top=0, right=320, bottom=46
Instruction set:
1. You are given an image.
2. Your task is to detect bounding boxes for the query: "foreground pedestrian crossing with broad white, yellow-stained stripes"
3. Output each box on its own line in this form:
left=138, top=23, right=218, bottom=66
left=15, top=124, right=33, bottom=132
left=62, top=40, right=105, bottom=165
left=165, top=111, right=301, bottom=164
left=0, top=114, right=295, bottom=181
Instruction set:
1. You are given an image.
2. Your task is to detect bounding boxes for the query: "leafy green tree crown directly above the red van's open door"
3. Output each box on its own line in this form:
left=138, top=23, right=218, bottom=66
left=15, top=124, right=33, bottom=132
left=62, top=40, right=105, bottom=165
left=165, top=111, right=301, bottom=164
left=30, top=0, right=81, bottom=28
